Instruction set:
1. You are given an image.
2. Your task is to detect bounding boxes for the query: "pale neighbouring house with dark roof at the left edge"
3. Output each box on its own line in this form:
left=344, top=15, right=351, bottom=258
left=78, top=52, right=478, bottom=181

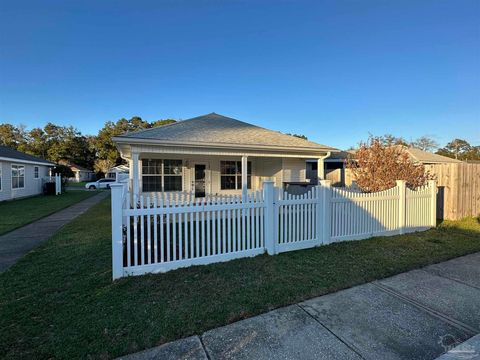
left=0, top=146, right=54, bottom=201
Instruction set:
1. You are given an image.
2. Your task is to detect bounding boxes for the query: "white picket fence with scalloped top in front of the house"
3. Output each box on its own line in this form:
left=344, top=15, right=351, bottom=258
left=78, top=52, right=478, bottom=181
left=111, top=180, right=436, bottom=279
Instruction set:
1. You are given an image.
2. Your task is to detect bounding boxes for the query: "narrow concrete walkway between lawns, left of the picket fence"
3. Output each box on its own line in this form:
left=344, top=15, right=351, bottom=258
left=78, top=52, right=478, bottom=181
left=0, top=191, right=109, bottom=272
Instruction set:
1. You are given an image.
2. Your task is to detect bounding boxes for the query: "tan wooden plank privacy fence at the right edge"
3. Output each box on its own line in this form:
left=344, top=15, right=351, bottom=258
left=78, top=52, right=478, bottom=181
left=425, top=163, right=480, bottom=220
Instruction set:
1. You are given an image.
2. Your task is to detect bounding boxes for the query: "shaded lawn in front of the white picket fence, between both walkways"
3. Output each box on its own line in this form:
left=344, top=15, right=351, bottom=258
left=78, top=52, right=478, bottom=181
left=0, top=199, right=480, bottom=359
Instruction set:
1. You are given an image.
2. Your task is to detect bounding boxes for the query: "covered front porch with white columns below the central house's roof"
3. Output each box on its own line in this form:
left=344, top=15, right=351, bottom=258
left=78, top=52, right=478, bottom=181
left=127, top=146, right=329, bottom=199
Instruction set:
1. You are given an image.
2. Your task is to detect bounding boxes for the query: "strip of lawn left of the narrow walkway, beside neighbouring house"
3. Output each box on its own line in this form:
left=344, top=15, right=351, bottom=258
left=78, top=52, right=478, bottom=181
left=0, top=191, right=99, bottom=235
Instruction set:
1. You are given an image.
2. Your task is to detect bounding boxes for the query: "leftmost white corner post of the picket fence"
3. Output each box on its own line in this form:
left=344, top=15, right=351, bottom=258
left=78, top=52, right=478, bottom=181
left=110, top=184, right=123, bottom=280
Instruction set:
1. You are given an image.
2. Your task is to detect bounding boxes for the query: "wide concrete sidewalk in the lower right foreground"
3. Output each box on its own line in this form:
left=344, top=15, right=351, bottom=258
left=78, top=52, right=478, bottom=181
left=119, top=253, right=480, bottom=360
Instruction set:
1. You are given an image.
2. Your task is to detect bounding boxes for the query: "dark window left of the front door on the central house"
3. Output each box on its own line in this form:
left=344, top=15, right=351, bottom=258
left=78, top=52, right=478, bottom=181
left=142, top=159, right=183, bottom=192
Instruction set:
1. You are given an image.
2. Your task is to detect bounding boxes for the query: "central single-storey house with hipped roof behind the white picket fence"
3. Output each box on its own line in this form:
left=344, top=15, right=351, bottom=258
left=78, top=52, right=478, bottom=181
left=113, top=113, right=338, bottom=197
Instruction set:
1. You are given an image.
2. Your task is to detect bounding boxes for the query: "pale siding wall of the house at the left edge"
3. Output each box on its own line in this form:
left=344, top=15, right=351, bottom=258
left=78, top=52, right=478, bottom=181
left=0, top=161, right=49, bottom=201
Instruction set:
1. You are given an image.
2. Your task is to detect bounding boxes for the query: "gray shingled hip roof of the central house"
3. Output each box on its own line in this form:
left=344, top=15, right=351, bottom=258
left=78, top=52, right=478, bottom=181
left=118, top=113, right=337, bottom=151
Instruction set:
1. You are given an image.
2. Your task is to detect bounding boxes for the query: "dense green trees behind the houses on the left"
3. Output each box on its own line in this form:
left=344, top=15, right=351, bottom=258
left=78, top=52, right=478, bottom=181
left=0, top=116, right=176, bottom=173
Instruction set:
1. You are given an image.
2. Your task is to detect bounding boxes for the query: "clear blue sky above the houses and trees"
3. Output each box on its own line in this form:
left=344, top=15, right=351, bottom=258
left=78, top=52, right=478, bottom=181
left=0, top=0, right=480, bottom=148
